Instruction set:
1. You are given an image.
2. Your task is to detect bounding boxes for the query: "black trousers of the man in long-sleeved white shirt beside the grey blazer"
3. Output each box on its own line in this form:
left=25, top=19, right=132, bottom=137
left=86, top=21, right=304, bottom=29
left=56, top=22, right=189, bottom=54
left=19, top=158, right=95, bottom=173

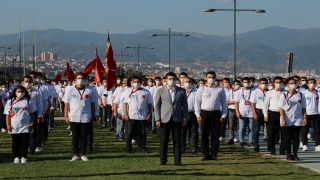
left=201, top=110, right=221, bottom=156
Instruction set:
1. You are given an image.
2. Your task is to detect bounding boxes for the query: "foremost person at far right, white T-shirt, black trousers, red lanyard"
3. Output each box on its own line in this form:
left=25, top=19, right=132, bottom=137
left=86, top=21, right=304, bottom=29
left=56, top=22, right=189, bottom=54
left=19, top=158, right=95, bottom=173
left=278, top=78, right=307, bottom=160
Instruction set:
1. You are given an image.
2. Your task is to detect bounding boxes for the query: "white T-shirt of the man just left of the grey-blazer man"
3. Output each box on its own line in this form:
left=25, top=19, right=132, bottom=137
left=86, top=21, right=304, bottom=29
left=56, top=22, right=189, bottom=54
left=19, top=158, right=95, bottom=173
left=124, top=89, right=152, bottom=120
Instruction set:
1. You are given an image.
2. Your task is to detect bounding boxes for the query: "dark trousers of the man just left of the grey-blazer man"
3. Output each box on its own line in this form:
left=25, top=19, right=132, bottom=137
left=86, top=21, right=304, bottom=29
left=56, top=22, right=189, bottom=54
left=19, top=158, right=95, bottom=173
left=126, top=119, right=147, bottom=151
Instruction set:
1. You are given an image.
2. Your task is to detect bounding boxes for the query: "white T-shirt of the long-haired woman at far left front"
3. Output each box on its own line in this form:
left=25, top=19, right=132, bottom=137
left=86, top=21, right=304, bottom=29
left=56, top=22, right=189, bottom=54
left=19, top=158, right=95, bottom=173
left=3, top=99, right=37, bottom=134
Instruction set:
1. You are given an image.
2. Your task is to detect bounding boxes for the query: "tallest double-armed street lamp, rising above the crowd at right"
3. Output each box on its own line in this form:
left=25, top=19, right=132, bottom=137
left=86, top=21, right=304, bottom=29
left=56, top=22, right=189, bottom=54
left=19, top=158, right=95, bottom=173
left=204, top=0, right=266, bottom=80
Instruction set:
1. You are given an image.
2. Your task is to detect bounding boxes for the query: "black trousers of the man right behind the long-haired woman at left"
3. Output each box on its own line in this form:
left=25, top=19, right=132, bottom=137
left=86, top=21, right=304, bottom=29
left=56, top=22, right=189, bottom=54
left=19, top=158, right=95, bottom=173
left=30, top=112, right=42, bottom=152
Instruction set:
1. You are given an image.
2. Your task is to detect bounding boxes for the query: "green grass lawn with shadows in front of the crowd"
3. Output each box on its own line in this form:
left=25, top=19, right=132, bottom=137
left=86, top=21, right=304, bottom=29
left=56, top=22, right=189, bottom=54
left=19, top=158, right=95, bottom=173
left=0, top=121, right=320, bottom=180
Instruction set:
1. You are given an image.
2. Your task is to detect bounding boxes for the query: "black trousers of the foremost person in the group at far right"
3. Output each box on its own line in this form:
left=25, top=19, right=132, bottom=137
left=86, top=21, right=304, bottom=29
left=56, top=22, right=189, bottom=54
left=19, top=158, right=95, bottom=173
left=282, top=126, right=301, bottom=155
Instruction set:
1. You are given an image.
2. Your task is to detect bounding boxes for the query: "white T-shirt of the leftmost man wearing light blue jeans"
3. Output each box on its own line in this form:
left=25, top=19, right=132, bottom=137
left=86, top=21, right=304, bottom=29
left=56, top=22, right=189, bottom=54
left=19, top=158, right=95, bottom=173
left=234, top=88, right=253, bottom=118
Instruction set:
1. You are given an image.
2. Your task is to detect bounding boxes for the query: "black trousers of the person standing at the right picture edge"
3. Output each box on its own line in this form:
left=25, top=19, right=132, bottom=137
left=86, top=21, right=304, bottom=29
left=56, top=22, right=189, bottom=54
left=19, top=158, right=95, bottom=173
left=302, top=114, right=320, bottom=146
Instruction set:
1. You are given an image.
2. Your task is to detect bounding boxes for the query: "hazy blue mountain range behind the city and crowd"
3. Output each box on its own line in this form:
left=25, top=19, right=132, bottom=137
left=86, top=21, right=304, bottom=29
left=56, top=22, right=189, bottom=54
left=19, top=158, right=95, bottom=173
left=0, top=27, right=320, bottom=72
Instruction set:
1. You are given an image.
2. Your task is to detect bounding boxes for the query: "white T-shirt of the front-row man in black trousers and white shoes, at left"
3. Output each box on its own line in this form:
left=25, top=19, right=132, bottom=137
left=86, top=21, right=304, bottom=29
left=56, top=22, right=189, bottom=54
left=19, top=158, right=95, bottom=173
left=64, top=86, right=96, bottom=123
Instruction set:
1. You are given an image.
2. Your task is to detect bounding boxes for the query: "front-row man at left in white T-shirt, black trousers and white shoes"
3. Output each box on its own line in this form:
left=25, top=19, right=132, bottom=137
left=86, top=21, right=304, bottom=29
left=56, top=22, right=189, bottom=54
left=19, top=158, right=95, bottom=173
left=64, top=72, right=96, bottom=161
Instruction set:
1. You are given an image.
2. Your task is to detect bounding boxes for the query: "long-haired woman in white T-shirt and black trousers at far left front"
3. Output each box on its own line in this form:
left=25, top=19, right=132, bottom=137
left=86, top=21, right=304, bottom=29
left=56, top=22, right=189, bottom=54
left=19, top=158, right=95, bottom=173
left=4, top=86, right=37, bottom=163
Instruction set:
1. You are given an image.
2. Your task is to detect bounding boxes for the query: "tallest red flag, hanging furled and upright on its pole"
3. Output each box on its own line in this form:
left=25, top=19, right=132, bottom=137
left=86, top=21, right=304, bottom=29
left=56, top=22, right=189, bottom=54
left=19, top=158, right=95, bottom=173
left=106, top=34, right=117, bottom=90
